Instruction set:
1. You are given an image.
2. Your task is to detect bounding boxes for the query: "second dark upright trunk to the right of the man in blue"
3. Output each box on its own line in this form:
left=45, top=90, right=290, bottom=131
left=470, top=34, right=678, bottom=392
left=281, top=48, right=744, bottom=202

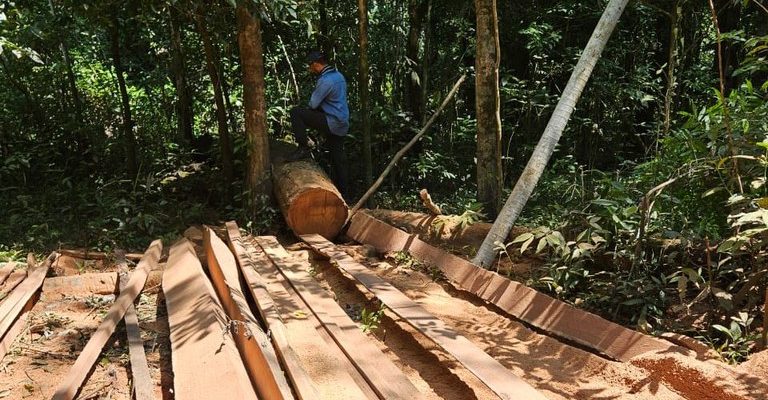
left=405, top=0, right=427, bottom=121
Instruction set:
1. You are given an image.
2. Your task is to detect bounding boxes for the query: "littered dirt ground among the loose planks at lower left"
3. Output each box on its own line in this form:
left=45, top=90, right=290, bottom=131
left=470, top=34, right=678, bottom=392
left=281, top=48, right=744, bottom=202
left=0, top=258, right=172, bottom=400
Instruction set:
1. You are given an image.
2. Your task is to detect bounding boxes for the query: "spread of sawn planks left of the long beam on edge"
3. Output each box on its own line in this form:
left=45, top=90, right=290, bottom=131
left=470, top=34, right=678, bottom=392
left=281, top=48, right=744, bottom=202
left=0, top=222, right=568, bottom=400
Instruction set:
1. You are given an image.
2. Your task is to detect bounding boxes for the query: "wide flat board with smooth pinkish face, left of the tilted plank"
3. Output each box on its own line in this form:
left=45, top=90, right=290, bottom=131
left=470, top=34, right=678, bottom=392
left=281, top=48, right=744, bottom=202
left=163, top=239, right=257, bottom=400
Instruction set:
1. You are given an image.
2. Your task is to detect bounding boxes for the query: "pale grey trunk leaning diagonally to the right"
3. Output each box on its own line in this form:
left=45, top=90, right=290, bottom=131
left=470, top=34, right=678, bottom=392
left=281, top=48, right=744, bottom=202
left=472, top=0, right=629, bottom=267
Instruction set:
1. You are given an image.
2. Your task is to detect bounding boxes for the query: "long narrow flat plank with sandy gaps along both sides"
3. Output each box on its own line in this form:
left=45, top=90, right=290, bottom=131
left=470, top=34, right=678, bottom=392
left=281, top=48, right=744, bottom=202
left=301, top=235, right=546, bottom=400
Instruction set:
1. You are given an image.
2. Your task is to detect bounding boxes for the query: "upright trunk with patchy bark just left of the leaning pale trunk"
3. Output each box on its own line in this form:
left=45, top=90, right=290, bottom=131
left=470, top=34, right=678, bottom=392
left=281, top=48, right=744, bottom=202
left=475, top=0, right=504, bottom=217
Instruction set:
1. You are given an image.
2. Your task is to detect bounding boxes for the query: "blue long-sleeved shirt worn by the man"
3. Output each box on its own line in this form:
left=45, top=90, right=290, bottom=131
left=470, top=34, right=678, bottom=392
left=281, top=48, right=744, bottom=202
left=309, top=65, right=349, bottom=136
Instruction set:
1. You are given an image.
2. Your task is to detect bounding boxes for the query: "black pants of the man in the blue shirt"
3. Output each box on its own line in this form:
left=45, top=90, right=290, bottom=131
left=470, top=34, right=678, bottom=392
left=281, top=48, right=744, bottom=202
left=291, top=107, right=349, bottom=201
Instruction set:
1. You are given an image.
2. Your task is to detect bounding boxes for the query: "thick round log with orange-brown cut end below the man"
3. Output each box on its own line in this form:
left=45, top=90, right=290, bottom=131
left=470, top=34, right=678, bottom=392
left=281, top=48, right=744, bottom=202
left=272, top=161, right=349, bottom=239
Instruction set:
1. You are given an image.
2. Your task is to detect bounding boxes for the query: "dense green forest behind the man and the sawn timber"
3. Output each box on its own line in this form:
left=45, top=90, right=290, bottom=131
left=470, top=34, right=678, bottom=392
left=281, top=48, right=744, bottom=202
left=0, top=0, right=768, bottom=361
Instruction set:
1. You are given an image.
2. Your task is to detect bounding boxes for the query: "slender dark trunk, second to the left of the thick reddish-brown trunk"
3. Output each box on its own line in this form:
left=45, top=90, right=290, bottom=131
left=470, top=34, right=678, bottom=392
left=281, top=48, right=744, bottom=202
left=168, top=6, right=199, bottom=150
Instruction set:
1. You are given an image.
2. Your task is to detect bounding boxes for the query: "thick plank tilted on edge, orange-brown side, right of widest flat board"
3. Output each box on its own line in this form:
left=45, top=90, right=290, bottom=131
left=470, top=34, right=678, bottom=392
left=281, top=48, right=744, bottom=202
left=203, top=227, right=293, bottom=400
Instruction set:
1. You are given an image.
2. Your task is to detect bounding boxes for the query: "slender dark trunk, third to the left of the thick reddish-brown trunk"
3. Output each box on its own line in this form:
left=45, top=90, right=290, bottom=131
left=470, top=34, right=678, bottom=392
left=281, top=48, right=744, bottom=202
left=109, top=12, right=139, bottom=177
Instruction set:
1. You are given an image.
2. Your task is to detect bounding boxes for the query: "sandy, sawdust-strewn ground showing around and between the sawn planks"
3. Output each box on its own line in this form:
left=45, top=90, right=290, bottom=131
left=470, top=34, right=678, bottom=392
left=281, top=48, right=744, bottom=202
left=0, top=227, right=768, bottom=400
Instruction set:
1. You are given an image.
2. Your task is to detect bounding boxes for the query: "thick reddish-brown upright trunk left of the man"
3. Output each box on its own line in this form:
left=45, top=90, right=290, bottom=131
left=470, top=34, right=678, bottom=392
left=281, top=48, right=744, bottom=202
left=236, top=2, right=271, bottom=212
